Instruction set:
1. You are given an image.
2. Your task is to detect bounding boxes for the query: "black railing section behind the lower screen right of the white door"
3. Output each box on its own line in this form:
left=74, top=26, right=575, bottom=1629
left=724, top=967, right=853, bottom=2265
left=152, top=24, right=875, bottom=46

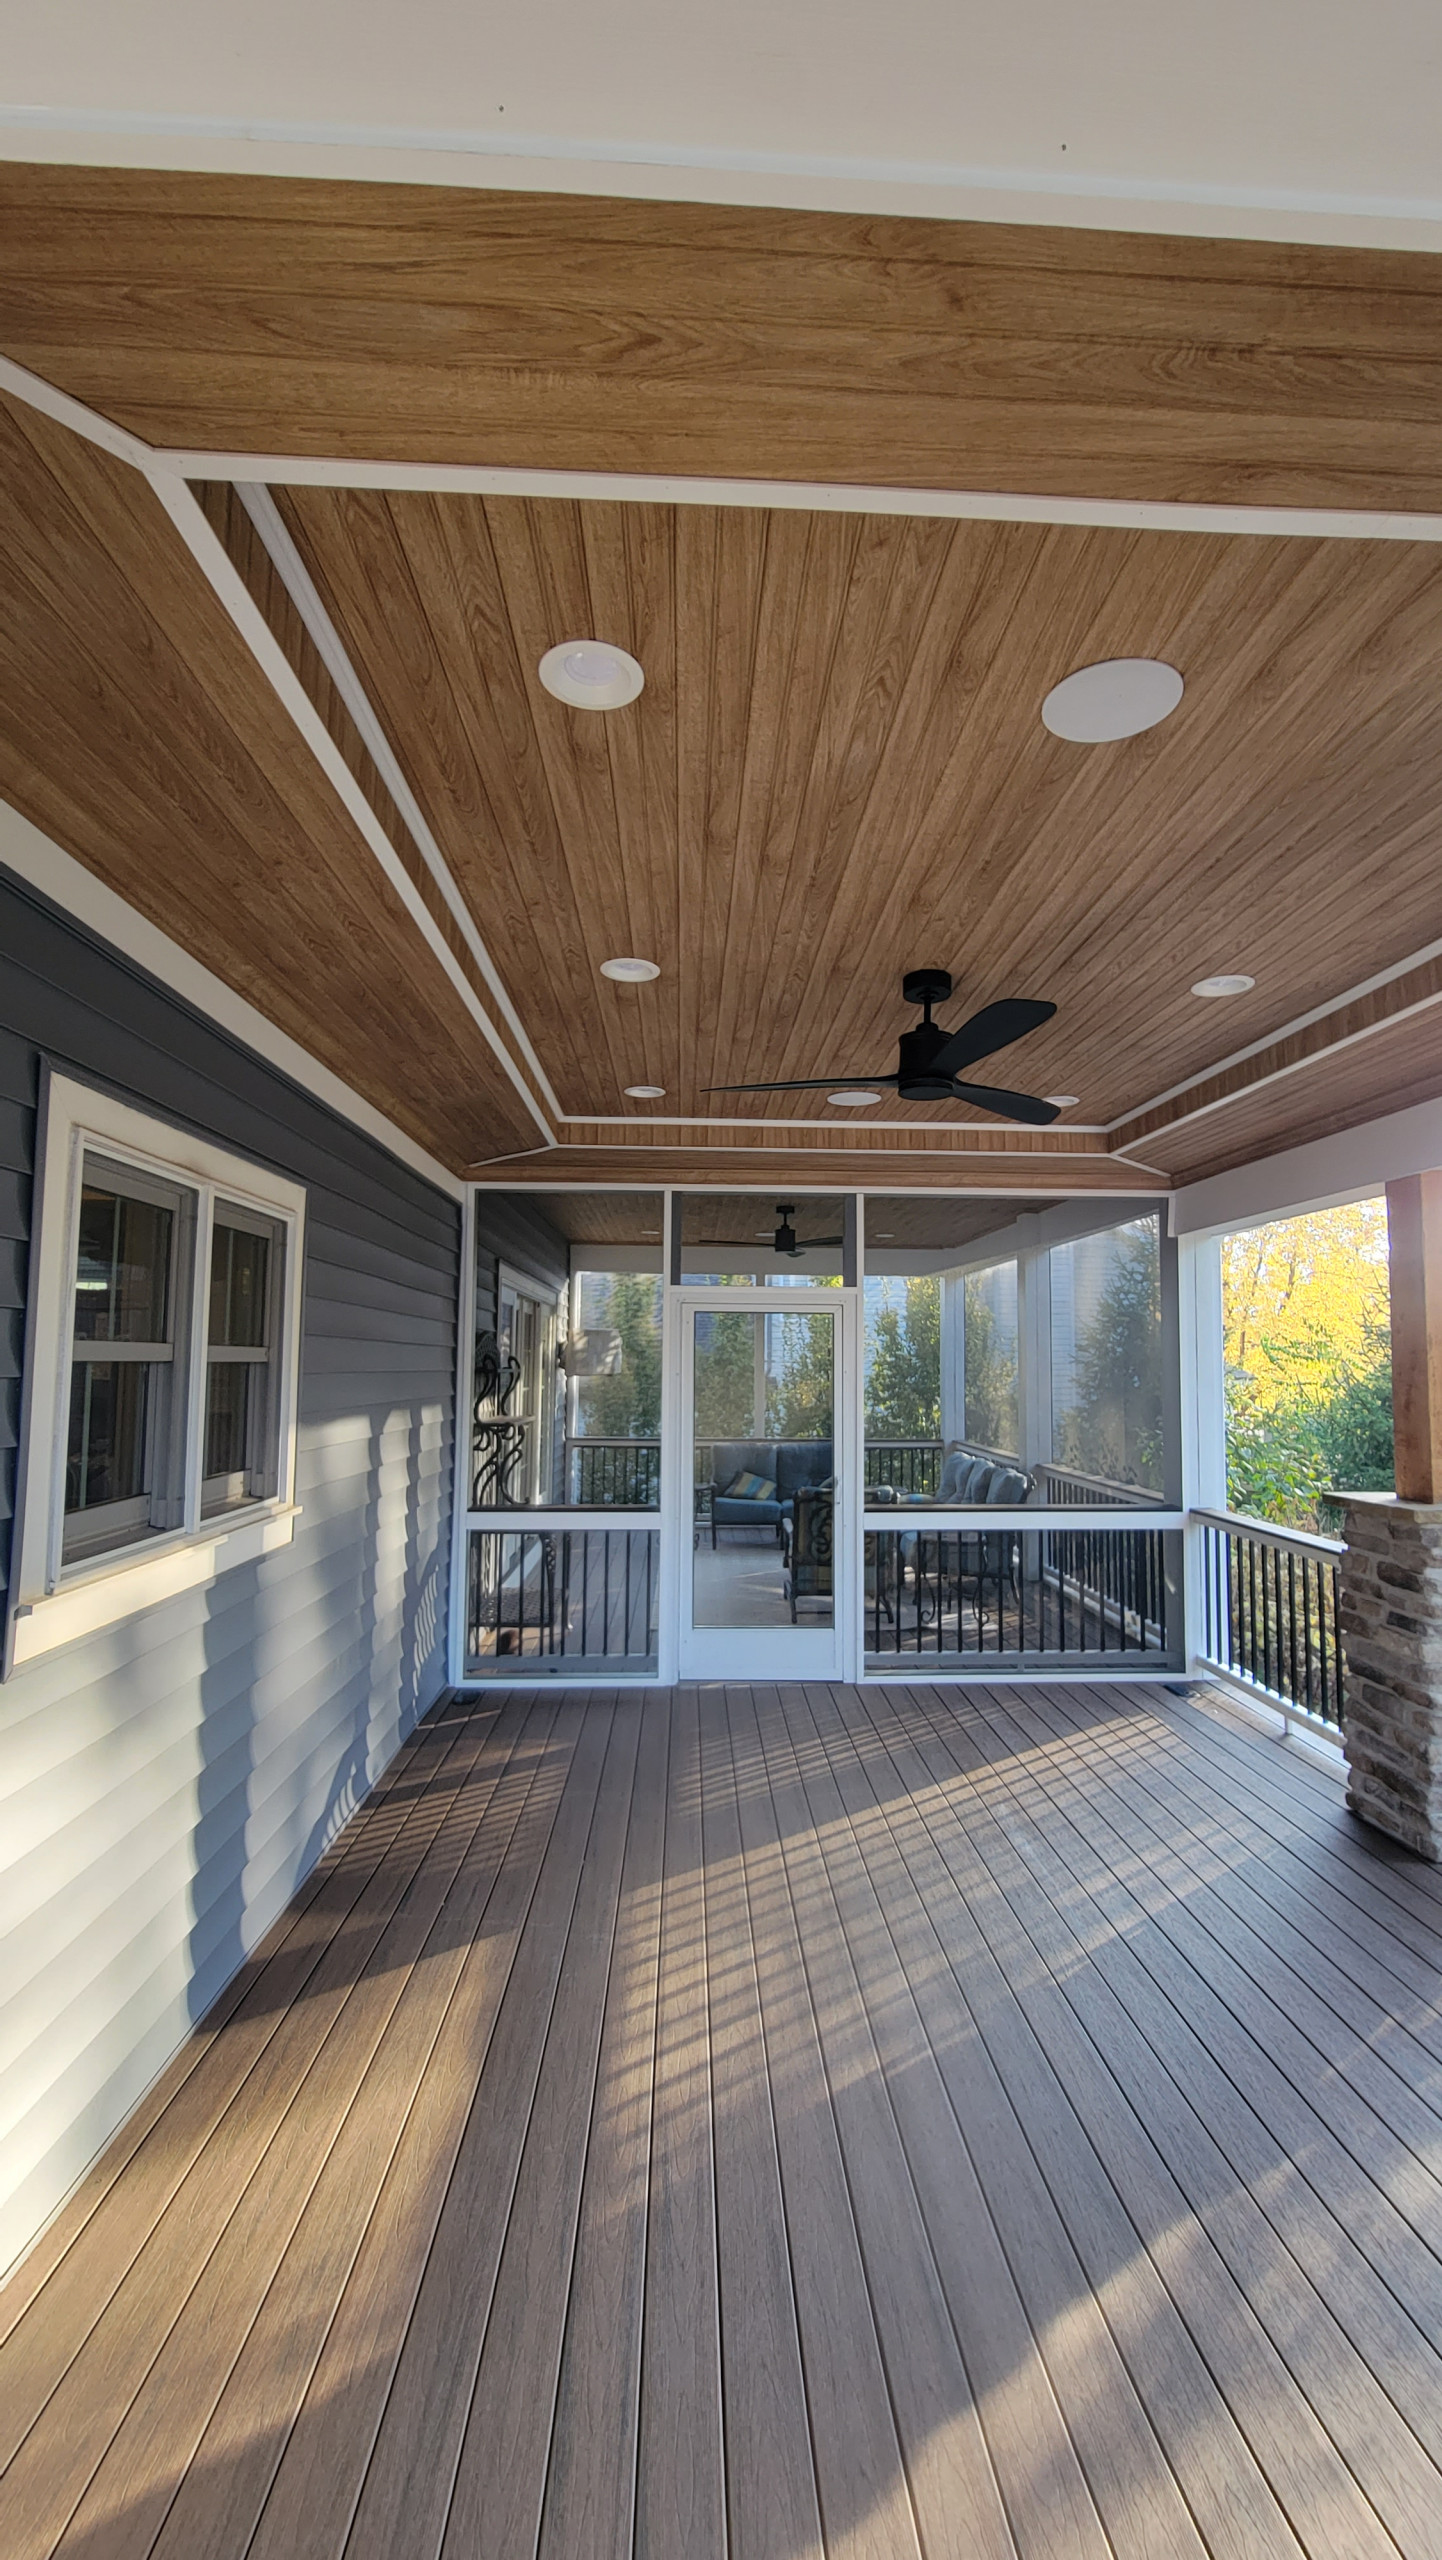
left=866, top=1526, right=1173, bottom=1669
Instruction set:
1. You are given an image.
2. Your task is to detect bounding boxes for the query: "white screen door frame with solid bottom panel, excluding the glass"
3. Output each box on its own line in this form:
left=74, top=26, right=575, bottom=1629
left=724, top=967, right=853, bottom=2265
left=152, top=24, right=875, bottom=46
left=661, top=1288, right=861, bottom=1679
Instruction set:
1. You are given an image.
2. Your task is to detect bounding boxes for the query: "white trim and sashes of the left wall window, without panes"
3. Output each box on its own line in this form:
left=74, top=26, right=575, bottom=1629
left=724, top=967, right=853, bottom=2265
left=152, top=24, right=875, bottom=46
left=5, top=1075, right=305, bottom=1672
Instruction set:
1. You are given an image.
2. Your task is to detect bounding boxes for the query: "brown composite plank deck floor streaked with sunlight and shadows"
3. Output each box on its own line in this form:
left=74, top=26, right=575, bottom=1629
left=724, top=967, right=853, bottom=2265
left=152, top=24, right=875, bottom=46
left=0, top=1684, right=1442, bottom=2560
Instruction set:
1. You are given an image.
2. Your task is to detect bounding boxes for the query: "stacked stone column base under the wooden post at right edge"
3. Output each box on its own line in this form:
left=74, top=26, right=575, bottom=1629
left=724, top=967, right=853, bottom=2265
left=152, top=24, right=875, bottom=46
left=1342, top=1498, right=1442, bottom=1859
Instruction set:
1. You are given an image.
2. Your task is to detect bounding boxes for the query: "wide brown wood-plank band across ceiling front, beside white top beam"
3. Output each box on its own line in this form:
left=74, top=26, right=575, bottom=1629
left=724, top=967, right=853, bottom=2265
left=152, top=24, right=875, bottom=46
left=0, top=164, right=1442, bottom=507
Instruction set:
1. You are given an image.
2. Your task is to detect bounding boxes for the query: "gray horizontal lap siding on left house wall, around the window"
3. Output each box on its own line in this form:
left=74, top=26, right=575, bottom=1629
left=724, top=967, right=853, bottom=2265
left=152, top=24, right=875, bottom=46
left=0, top=873, right=458, bottom=2268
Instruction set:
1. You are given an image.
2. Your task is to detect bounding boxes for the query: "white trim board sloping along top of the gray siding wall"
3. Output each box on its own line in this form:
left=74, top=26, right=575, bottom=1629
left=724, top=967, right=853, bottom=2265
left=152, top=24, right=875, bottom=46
left=0, top=801, right=466, bottom=1201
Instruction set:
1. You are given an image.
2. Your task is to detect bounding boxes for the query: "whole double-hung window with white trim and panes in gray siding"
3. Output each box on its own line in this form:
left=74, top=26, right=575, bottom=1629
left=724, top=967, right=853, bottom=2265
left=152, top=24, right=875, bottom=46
left=10, top=1075, right=305, bottom=1659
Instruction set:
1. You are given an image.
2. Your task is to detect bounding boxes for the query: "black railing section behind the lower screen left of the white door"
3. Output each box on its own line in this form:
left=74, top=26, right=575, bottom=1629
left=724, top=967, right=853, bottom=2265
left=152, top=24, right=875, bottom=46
left=466, top=1526, right=661, bottom=1677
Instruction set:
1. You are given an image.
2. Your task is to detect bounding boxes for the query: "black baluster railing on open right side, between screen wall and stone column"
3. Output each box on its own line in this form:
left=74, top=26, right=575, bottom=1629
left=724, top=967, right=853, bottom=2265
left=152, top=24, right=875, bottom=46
left=1196, top=1513, right=1342, bottom=1725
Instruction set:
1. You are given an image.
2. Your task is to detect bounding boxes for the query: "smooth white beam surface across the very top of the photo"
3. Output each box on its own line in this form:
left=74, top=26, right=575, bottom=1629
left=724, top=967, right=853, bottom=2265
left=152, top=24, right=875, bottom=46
left=0, top=0, right=1442, bottom=248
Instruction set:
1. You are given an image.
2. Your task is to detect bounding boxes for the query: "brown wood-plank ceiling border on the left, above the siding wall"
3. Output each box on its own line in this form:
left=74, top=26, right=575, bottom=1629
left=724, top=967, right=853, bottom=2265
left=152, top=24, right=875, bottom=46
left=0, top=399, right=538, bottom=1165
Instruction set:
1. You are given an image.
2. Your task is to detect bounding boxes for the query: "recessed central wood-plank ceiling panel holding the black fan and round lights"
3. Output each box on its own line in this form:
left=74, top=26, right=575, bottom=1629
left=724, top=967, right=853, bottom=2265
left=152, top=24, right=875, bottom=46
left=282, top=489, right=1442, bottom=1160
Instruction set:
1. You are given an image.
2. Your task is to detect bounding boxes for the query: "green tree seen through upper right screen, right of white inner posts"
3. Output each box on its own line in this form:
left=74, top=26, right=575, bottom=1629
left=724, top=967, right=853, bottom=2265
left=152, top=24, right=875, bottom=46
left=1055, top=1221, right=1163, bottom=1490
